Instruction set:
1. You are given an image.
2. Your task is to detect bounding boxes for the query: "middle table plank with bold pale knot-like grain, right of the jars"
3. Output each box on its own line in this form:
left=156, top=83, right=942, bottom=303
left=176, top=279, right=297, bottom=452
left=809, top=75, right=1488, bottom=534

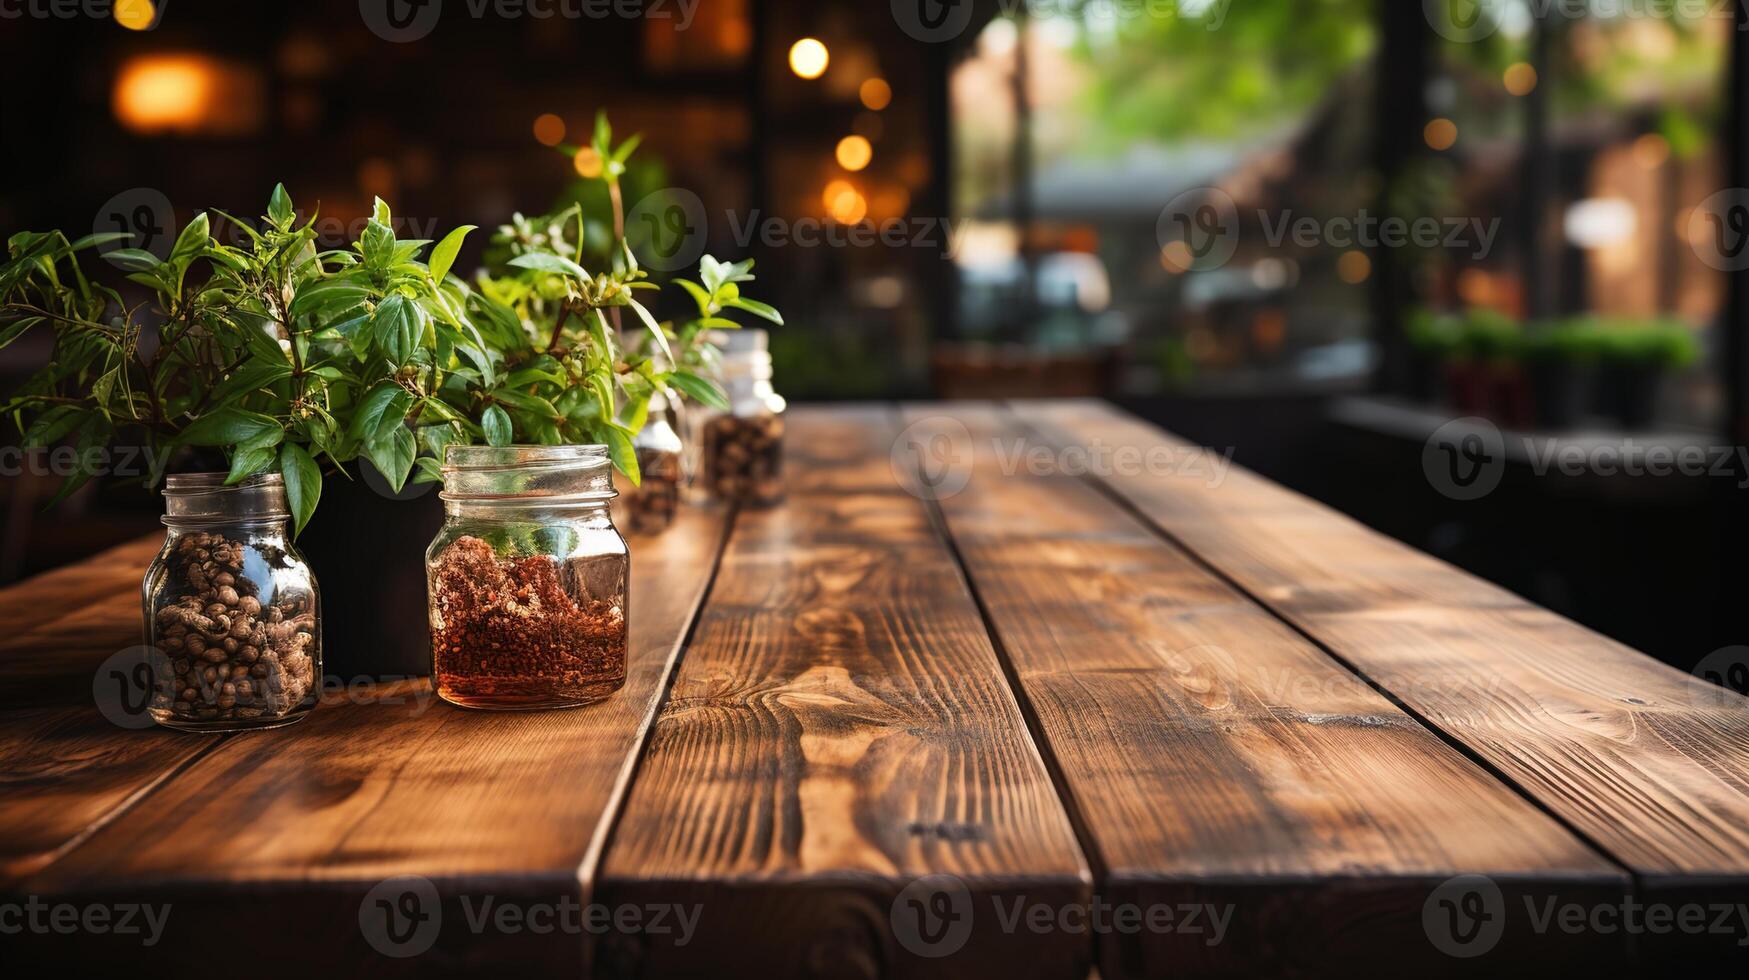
left=602, top=410, right=1091, bottom=980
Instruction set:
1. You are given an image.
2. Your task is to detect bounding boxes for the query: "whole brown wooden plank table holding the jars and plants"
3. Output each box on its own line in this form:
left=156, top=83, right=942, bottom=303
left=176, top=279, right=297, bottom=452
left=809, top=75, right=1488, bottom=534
left=0, top=403, right=1749, bottom=978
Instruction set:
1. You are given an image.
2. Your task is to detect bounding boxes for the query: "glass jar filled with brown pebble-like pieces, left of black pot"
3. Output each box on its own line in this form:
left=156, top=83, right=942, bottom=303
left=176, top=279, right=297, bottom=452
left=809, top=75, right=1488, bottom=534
left=143, top=473, right=322, bottom=732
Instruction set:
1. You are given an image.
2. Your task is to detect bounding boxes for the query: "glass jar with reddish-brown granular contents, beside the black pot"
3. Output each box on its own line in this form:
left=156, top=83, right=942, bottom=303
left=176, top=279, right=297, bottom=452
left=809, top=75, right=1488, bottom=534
left=425, top=446, right=631, bottom=709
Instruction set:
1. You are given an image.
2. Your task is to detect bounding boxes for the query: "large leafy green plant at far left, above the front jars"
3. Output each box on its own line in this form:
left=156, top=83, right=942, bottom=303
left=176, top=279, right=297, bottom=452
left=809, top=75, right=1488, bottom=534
left=0, top=186, right=479, bottom=530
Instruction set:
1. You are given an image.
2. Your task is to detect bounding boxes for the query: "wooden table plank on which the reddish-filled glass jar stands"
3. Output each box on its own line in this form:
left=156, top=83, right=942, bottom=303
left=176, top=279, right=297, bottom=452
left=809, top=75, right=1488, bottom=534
left=19, top=508, right=728, bottom=977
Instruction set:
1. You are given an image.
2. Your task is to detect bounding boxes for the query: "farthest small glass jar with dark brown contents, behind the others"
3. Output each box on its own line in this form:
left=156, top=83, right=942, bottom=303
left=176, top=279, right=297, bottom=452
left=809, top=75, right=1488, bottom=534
left=700, top=329, right=784, bottom=506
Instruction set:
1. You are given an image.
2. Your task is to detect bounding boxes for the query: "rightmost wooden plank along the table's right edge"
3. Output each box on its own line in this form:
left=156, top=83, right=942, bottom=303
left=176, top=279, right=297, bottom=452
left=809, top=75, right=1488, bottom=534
left=1016, top=403, right=1749, bottom=964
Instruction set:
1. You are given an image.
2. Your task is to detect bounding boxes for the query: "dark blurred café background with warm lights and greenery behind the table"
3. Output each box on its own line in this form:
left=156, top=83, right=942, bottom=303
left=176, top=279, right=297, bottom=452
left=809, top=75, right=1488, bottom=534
left=0, top=0, right=1749, bottom=669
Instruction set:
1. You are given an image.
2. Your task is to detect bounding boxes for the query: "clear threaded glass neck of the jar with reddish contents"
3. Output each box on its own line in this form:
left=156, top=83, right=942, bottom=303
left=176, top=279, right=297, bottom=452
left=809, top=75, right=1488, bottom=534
left=439, top=446, right=619, bottom=506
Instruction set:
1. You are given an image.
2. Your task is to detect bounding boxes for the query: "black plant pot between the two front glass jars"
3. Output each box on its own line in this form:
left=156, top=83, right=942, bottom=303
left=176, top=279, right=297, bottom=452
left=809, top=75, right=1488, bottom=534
left=297, top=464, right=442, bottom=681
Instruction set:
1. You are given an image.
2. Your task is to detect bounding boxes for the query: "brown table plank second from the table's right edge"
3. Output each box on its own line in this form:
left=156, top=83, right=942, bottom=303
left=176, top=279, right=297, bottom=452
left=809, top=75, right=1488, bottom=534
left=906, top=404, right=1627, bottom=978
